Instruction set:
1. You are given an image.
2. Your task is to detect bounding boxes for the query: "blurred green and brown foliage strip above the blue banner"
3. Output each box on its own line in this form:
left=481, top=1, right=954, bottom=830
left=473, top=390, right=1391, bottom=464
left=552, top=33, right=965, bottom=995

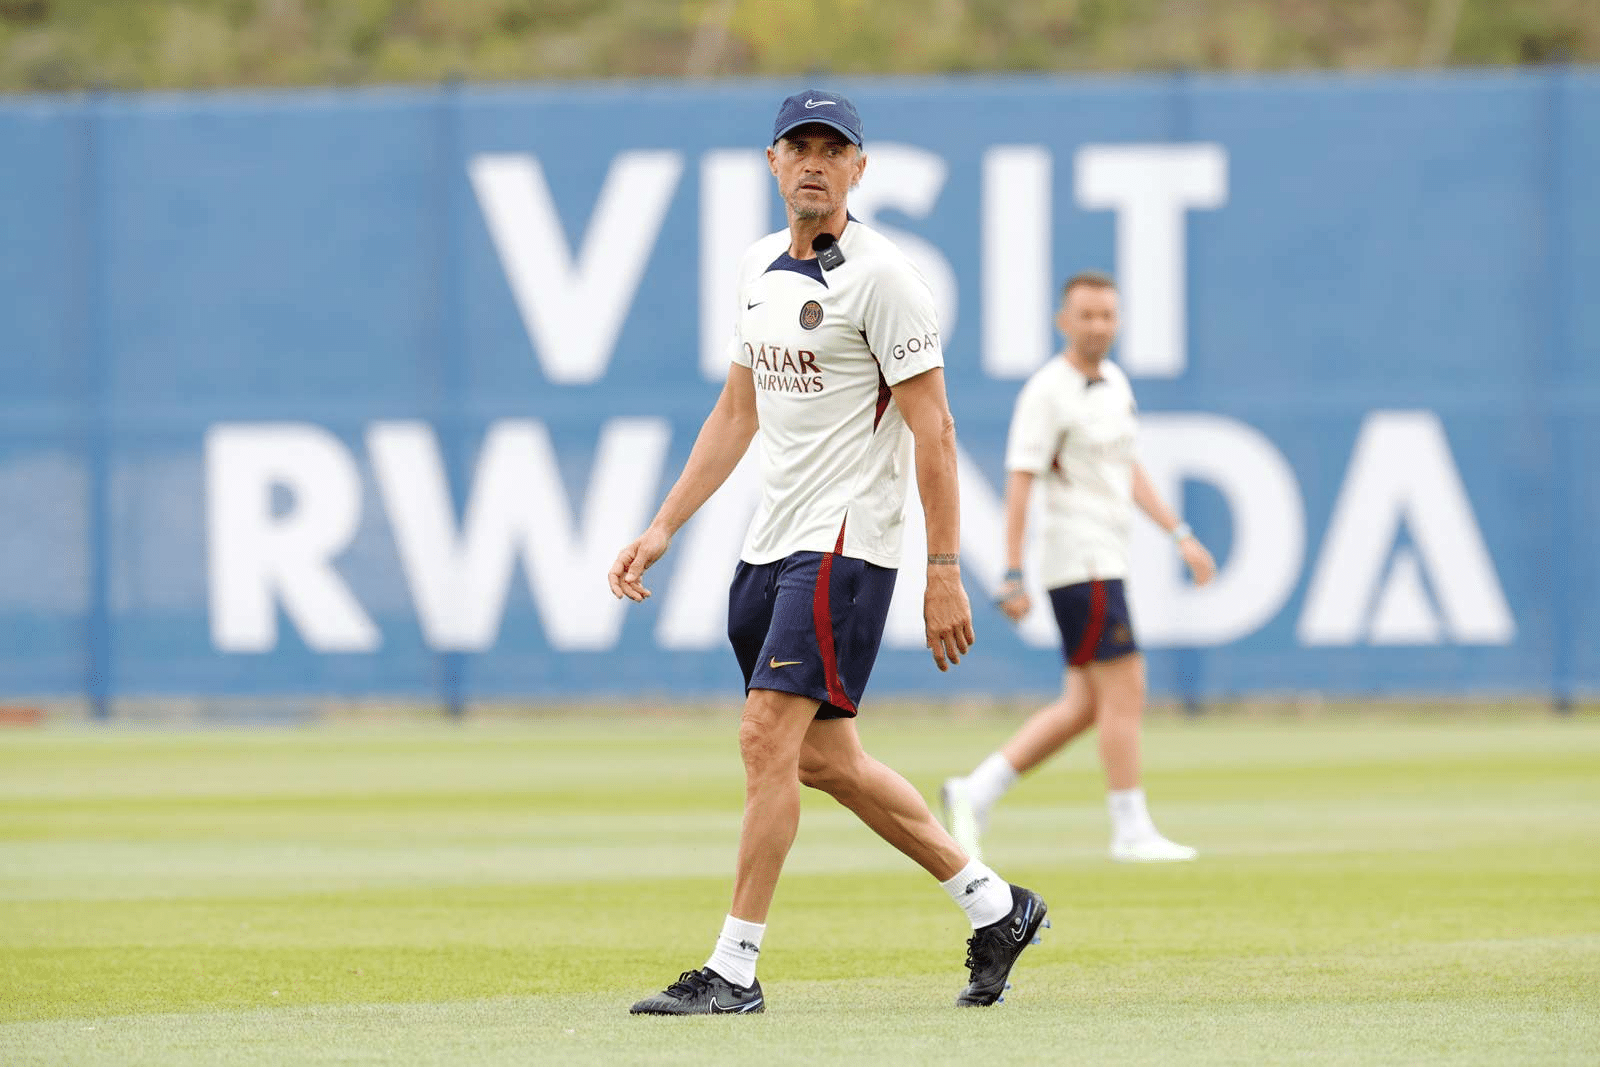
left=0, top=0, right=1600, bottom=91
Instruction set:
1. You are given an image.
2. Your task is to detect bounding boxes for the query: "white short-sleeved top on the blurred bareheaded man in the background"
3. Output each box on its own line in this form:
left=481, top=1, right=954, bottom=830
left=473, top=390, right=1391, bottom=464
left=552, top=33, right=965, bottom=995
left=1005, top=354, right=1138, bottom=589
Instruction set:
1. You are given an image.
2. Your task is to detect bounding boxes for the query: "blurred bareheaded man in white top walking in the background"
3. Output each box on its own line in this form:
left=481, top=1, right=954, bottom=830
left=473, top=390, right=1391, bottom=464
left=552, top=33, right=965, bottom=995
left=942, top=272, right=1216, bottom=862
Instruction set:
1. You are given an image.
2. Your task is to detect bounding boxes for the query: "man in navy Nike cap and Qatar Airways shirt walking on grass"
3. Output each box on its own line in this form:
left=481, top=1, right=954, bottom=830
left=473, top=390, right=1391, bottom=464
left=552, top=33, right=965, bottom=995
left=610, top=91, right=1046, bottom=1014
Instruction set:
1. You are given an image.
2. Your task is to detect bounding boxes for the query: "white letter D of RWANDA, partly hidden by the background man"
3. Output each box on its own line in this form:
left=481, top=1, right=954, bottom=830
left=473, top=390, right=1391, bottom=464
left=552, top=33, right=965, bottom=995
left=1128, top=414, right=1306, bottom=648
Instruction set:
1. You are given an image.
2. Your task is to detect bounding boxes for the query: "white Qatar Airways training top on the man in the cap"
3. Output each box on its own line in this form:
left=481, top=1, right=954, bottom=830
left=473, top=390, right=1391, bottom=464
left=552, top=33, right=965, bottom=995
left=730, top=219, right=944, bottom=566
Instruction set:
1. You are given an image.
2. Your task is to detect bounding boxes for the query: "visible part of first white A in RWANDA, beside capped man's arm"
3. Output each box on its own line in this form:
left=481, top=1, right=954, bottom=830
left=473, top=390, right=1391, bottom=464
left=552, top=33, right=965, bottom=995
left=659, top=438, right=762, bottom=651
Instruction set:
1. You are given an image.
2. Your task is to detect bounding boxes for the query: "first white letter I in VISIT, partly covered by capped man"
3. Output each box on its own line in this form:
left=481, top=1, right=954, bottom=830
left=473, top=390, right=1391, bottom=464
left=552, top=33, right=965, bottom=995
left=699, top=149, right=773, bottom=382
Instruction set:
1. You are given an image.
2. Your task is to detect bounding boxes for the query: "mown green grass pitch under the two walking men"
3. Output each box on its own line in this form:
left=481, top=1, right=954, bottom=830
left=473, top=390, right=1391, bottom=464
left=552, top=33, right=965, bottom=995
left=0, top=712, right=1600, bottom=1067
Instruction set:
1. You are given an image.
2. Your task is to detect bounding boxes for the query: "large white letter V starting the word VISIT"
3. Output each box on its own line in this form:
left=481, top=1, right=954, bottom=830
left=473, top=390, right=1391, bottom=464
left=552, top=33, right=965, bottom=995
left=469, top=152, right=683, bottom=386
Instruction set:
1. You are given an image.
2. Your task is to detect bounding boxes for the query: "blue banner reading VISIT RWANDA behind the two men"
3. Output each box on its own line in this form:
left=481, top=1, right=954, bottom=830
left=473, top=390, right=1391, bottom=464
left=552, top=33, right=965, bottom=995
left=0, top=70, right=1600, bottom=705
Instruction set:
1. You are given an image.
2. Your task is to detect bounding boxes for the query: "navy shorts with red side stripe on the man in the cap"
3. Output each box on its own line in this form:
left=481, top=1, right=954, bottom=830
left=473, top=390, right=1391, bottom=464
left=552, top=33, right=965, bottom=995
left=728, top=552, right=894, bottom=718
